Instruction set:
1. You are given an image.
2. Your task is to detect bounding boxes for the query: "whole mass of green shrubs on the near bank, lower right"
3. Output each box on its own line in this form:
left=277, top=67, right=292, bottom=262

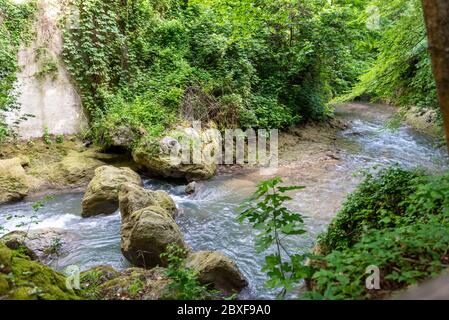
left=307, top=167, right=449, bottom=299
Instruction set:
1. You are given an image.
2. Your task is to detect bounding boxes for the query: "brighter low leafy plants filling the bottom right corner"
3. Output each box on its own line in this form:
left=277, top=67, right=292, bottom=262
left=306, top=219, right=449, bottom=299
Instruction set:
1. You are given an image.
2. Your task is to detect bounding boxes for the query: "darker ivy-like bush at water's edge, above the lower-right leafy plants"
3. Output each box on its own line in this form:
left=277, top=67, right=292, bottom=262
left=319, top=166, right=425, bottom=253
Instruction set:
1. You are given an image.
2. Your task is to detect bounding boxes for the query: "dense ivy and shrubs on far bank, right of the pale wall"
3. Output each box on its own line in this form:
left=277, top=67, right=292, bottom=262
left=64, top=0, right=372, bottom=148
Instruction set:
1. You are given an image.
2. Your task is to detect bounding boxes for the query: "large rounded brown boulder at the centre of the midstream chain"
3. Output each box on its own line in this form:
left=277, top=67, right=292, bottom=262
left=121, top=206, right=187, bottom=268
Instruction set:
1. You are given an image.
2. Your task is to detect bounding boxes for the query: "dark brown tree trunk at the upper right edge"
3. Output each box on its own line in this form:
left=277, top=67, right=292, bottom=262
left=423, top=0, right=449, bottom=151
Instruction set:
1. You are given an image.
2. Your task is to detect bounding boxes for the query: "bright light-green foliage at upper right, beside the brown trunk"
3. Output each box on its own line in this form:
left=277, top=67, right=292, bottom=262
left=346, top=0, right=439, bottom=115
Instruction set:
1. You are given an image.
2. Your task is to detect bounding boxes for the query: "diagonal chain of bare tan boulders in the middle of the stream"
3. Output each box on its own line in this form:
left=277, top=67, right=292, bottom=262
left=83, top=166, right=247, bottom=292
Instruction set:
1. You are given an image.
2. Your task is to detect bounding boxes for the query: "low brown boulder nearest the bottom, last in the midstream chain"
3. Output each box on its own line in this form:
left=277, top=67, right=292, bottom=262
left=186, top=251, right=248, bottom=294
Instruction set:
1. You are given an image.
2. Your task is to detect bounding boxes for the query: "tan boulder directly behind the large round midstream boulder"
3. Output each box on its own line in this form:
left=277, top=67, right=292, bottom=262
left=118, top=183, right=177, bottom=220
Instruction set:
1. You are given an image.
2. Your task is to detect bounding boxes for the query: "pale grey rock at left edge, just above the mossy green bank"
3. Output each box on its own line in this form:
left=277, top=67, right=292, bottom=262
left=0, top=229, right=71, bottom=265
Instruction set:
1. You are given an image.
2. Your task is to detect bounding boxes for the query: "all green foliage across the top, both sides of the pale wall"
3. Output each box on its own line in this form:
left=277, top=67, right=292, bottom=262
left=0, top=0, right=438, bottom=144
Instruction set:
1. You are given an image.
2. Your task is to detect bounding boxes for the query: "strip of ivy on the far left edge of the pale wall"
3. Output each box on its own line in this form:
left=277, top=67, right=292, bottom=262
left=0, top=0, right=36, bottom=142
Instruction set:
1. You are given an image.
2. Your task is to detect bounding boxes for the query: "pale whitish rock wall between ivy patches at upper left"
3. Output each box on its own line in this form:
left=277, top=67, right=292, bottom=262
left=6, top=0, right=87, bottom=139
